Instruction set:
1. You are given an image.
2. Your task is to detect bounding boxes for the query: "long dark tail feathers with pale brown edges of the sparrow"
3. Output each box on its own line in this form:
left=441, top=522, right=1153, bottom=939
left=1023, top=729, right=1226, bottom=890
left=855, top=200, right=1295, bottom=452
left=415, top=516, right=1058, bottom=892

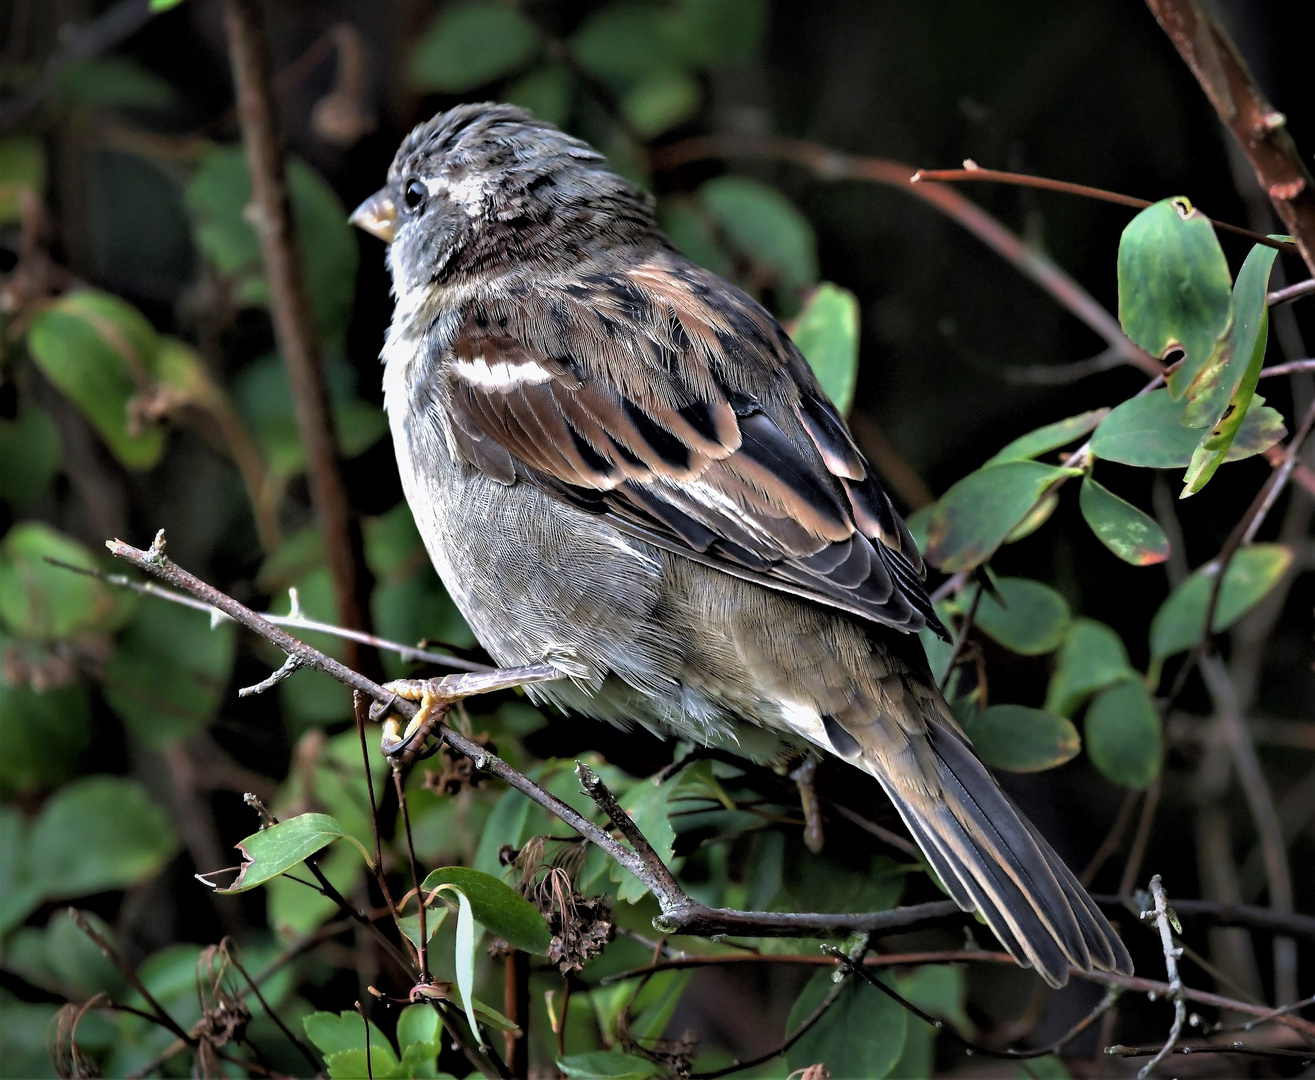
left=851, top=688, right=1132, bottom=987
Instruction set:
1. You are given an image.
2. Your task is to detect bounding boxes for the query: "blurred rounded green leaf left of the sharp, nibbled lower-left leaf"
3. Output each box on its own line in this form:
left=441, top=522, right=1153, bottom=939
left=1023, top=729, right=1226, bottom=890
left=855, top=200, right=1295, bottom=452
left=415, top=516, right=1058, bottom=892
left=28, top=776, right=178, bottom=900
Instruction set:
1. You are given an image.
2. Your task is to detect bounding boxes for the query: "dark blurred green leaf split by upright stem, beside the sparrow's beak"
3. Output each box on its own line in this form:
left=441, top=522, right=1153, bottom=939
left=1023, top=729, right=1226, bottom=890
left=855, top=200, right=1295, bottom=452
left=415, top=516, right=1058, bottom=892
left=185, top=146, right=359, bottom=347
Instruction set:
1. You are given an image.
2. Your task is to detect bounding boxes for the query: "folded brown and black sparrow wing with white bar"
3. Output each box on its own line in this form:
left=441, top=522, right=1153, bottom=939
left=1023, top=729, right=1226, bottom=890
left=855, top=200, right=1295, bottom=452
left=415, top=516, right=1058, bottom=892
left=442, top=250, right=945, bottom=635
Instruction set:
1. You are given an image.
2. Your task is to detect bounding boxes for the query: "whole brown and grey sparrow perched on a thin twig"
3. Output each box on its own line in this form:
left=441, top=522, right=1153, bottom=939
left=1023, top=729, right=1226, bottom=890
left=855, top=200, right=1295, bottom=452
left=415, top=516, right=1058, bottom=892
left=351, top=103, right=1132, bottom=987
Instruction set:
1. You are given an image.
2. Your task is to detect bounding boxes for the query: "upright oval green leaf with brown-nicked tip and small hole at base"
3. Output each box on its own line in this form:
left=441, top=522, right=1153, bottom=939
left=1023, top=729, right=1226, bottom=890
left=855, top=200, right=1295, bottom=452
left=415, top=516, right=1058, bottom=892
left=1119, top=196, right=1233, bottom=400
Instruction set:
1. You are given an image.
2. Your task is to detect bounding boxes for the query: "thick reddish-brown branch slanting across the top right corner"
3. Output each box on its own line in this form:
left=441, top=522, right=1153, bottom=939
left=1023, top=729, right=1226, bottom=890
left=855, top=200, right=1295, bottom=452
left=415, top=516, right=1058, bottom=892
left=1147, top=0, right=1315, bottom=275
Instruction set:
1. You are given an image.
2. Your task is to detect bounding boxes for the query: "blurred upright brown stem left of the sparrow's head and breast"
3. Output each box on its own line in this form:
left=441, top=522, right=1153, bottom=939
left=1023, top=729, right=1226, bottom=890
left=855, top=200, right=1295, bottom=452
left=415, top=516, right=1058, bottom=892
left=225, top=0, right=379, bottom=668
